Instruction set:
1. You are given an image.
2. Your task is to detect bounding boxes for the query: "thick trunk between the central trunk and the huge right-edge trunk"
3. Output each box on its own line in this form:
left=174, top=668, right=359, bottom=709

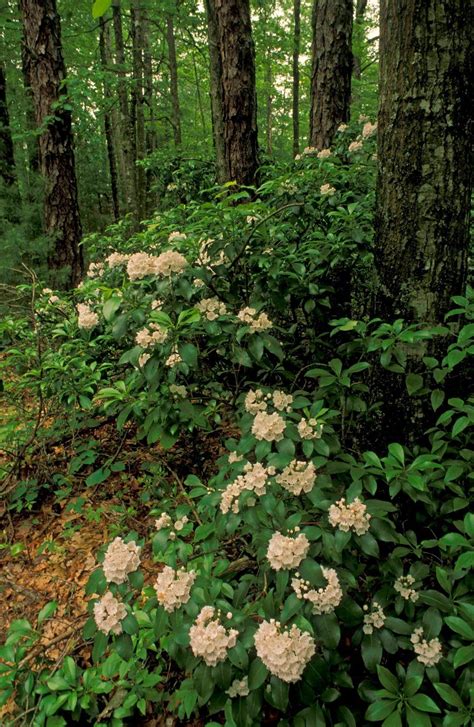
left=309, top=0, right=353, bottom=149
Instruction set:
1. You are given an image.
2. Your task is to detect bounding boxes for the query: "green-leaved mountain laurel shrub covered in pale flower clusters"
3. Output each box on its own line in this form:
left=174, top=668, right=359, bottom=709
left=0, top=119, right=474, bottom=727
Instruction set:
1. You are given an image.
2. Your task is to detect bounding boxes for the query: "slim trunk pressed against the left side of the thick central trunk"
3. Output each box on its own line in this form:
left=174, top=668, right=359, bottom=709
left=205, top=0, right=227, bottom=184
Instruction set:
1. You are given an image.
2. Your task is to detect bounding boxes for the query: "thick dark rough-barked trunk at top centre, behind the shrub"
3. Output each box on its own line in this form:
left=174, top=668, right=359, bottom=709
left=214, top=0, right=258, bottom=185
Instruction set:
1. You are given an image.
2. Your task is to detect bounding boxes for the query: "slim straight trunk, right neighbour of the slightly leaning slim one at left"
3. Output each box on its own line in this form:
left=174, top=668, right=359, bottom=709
left=131, top=0, right=146, bottom=220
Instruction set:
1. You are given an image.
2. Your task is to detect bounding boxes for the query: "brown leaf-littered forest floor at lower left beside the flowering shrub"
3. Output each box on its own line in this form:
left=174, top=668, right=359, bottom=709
left=0, top=398, right=230, bottom=727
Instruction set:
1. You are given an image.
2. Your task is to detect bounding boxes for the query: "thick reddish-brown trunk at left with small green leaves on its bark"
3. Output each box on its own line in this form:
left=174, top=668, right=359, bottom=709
left=20, top=0, right=83, bottom=285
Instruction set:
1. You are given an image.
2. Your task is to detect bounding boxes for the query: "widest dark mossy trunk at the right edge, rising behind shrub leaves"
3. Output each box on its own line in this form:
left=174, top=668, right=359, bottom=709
left=375, top=0, right=473, bottom=323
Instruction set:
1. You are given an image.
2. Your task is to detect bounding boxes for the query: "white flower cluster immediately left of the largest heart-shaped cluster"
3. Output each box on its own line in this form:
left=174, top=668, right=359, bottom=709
left=189, top=606, right=239, bottom=666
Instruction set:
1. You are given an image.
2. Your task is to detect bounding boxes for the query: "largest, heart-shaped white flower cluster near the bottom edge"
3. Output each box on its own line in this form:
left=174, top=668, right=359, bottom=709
left=254, top=619, right=316, bottom=683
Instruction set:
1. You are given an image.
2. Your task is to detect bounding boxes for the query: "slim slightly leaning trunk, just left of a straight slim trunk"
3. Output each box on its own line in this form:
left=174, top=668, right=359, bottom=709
left=112, top=0, right=136, bottom=215
